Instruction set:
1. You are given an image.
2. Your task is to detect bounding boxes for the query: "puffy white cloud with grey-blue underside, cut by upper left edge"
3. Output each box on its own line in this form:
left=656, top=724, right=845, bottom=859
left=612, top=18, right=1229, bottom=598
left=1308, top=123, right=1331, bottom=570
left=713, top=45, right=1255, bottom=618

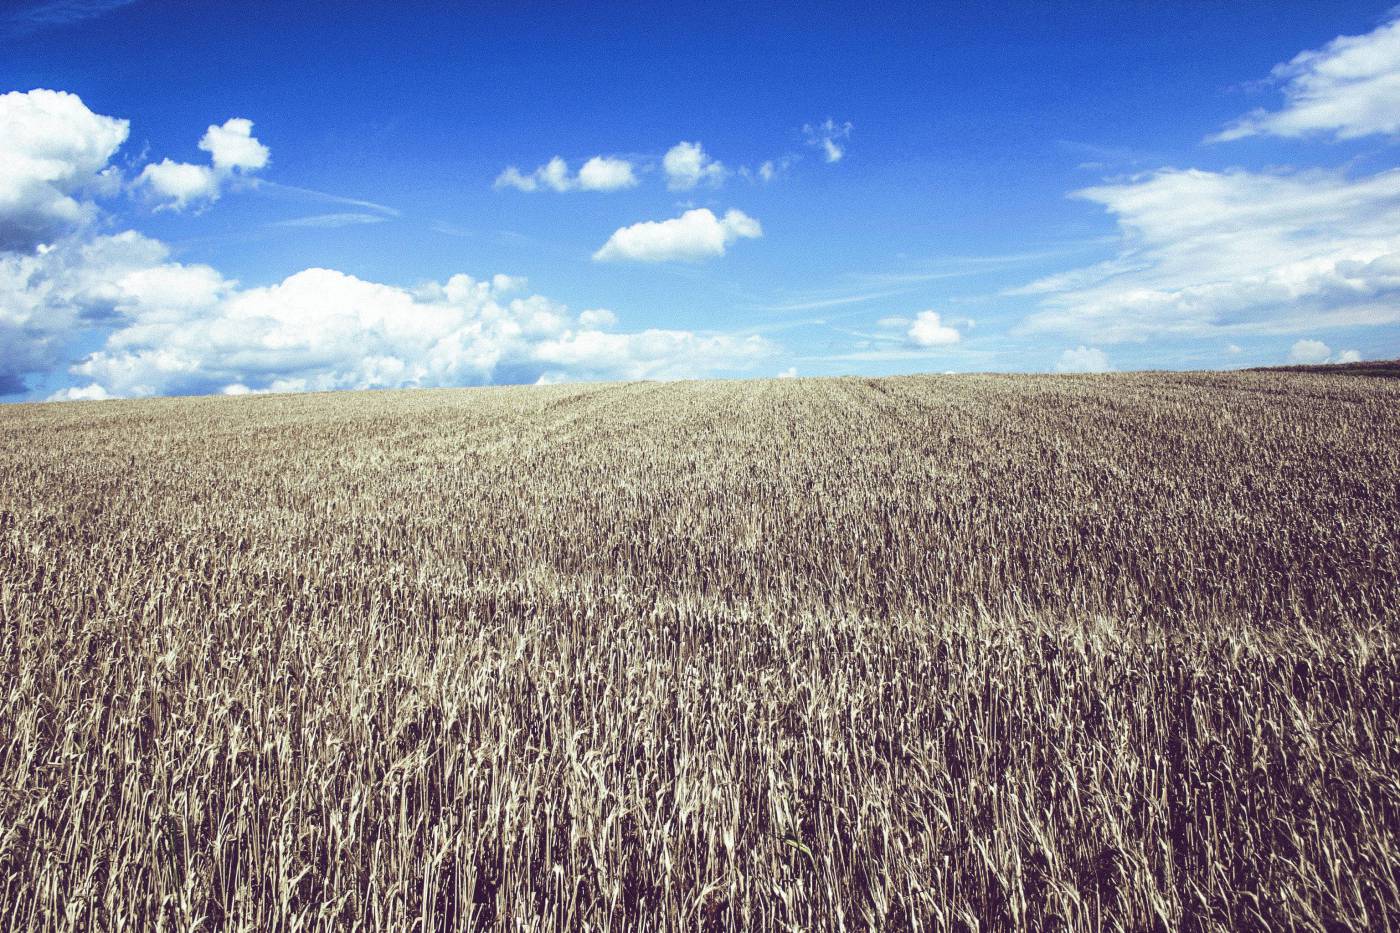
left=0, top=88, right=129, bottom=249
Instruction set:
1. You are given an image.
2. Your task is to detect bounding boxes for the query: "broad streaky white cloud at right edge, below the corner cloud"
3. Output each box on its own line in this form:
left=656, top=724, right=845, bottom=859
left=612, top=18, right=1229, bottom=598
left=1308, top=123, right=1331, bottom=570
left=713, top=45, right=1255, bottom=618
left=1019, top=170, right=1400, bottom=343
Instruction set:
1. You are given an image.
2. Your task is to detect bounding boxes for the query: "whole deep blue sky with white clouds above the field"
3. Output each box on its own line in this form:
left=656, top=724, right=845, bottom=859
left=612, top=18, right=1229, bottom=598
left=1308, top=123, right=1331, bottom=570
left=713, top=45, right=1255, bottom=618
left=0, top=0, right=1400, bottom=401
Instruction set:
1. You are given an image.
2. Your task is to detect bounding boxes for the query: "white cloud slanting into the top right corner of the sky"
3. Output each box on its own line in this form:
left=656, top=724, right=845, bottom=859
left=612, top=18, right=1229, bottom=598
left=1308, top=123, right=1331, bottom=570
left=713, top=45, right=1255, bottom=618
left=1211, top=8, right=1400, bottom=141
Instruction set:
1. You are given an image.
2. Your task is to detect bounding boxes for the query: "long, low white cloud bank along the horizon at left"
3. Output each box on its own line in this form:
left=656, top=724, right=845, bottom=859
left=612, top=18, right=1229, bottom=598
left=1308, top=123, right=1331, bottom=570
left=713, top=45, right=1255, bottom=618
left=0, top=222, right=776, bottom=398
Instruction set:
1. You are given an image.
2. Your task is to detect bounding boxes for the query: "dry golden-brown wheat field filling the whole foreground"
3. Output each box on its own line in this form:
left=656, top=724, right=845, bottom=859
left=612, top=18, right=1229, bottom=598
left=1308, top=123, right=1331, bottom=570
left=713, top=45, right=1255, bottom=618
left=0, top=373, right=1400, bottom=933
